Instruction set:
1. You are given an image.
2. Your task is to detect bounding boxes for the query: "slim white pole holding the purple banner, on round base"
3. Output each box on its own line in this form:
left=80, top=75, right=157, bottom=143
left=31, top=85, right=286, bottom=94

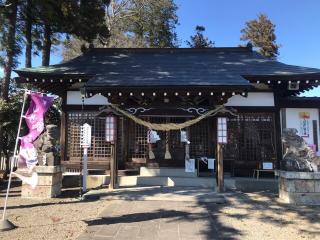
left=0, top=90, right=29, bottom=230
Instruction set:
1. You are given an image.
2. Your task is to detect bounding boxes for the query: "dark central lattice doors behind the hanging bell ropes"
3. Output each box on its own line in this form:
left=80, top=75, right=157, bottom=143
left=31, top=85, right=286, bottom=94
left=128, top=116, right=215, bottom=167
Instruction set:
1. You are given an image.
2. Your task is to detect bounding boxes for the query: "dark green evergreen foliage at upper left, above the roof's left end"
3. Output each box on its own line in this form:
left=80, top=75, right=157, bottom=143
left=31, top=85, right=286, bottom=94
left=25, top=0, right=109, bottom=66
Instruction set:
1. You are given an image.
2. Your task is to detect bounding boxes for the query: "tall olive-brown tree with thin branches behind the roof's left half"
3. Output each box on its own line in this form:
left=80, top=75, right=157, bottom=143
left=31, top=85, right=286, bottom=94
left=63, top=0, right=178, bottom=60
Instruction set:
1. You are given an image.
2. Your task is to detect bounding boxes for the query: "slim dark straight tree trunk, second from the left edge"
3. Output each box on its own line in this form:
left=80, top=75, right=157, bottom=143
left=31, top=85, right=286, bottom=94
left=25, top=0, right=32, bottom=68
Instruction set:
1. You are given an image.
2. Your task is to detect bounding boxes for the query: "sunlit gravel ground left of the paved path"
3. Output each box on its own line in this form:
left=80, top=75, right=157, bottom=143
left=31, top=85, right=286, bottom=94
left=0, top=182, right=109, bottom=240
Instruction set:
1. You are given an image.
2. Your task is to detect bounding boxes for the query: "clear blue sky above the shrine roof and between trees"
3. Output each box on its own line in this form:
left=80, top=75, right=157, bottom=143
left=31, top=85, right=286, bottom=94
left=0, top=0, right=320, bottom=97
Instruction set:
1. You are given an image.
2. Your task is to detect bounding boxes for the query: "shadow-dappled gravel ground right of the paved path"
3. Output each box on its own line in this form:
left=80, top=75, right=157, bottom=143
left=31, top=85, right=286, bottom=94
left=219, top=193, right=320, bottom=240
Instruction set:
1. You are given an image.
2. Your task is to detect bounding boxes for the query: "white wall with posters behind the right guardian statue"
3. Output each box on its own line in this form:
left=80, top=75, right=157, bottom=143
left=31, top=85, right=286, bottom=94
left=285, top=108, right=320, bottom=155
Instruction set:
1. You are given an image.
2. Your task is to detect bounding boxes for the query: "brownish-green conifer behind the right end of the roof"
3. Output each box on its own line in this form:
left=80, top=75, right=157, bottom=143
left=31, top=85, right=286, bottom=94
left=240, top=14, right=280, bottom=58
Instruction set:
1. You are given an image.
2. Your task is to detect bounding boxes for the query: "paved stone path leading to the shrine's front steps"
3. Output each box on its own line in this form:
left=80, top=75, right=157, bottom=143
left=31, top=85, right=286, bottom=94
left=78, top=187, right=230, bottom=240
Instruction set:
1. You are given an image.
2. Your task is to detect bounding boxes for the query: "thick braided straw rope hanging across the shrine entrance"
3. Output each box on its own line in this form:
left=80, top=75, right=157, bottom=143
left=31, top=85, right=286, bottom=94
left=110, top=104, right=235, bottom=131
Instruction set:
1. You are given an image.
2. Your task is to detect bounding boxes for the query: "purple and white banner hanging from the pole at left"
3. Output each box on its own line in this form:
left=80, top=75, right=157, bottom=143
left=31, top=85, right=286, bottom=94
left=19, top=93, right=54, bottom=170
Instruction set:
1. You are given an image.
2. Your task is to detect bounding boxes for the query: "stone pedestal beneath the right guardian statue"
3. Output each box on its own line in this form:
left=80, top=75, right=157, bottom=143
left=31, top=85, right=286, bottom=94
left=279, top=171, right=320, bottom=205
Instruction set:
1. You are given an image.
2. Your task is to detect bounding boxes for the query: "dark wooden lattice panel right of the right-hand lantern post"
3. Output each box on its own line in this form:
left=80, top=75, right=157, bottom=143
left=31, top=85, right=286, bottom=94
left=225, top=113, right=276, bottom=176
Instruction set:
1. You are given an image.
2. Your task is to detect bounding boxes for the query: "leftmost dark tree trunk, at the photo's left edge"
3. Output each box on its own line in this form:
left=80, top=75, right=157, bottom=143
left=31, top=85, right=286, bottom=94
left=1, top=0, right=18, bottom=100
